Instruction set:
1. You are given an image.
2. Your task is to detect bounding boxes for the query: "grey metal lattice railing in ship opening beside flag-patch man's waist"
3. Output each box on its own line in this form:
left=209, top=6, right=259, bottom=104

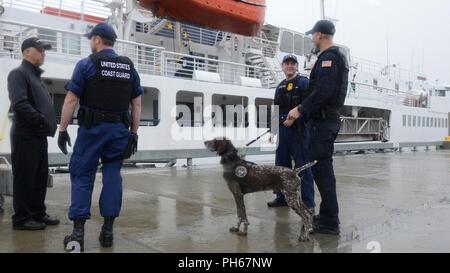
left=339, top=117, right=384, bottom=135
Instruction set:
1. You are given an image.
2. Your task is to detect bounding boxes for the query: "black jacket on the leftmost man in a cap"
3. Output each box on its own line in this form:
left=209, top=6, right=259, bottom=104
left=8, top=60, right=56, bottom=137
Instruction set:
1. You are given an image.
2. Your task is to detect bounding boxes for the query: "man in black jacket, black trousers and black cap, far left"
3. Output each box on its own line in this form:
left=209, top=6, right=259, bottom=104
left=8, top=37, right=59, bottom=230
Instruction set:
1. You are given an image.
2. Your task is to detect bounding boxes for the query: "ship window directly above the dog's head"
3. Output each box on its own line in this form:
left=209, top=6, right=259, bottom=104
left=211, top=94, right=248, bottom=128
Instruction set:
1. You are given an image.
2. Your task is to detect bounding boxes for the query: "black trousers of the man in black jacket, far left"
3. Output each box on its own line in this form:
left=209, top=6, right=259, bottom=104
left=11, top=135, right=48, bottom=225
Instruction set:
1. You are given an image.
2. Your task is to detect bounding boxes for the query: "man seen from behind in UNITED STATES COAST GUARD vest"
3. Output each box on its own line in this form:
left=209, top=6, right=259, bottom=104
left=58, top=24, right=142, bottom=251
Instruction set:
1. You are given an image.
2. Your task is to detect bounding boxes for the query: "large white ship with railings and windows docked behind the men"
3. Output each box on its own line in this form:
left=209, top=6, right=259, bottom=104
left=0, top=2, right=450, bottom=163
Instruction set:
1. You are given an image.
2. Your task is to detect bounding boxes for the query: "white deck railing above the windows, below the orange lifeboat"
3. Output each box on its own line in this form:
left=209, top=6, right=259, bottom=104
left=162, top=51, right=272, bottom=88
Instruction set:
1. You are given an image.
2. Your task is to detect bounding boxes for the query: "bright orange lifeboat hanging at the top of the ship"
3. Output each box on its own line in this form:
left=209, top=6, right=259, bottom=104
left=139, top=0, right=266, bottom=36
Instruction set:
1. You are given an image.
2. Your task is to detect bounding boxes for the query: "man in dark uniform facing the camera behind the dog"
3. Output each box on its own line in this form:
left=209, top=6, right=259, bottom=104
left=267, top=54, right=315, bottom=212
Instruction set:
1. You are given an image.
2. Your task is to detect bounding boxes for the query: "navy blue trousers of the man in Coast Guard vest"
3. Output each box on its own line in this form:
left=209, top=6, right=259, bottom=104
left=69, top=123, right=130, bottom=220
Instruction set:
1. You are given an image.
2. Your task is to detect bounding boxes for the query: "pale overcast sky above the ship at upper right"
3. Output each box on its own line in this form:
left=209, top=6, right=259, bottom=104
left=266, top=0, right=450, bottom=84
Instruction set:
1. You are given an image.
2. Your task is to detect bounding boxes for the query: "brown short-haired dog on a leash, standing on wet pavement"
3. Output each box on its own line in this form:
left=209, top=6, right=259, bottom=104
left=205, top=138, right=315, bottom=241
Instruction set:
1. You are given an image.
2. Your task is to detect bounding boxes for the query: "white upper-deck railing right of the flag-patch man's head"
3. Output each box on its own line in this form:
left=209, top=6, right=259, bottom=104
left=352, top=57, right=427, bottom=83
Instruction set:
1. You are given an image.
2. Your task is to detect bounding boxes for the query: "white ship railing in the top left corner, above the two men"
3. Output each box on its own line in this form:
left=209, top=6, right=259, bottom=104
left=0, top=0, right=111, bottom=20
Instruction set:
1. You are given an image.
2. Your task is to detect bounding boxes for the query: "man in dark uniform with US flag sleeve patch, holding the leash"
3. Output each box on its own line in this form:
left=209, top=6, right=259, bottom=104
left=288, top=20, right=349, bottom=235
